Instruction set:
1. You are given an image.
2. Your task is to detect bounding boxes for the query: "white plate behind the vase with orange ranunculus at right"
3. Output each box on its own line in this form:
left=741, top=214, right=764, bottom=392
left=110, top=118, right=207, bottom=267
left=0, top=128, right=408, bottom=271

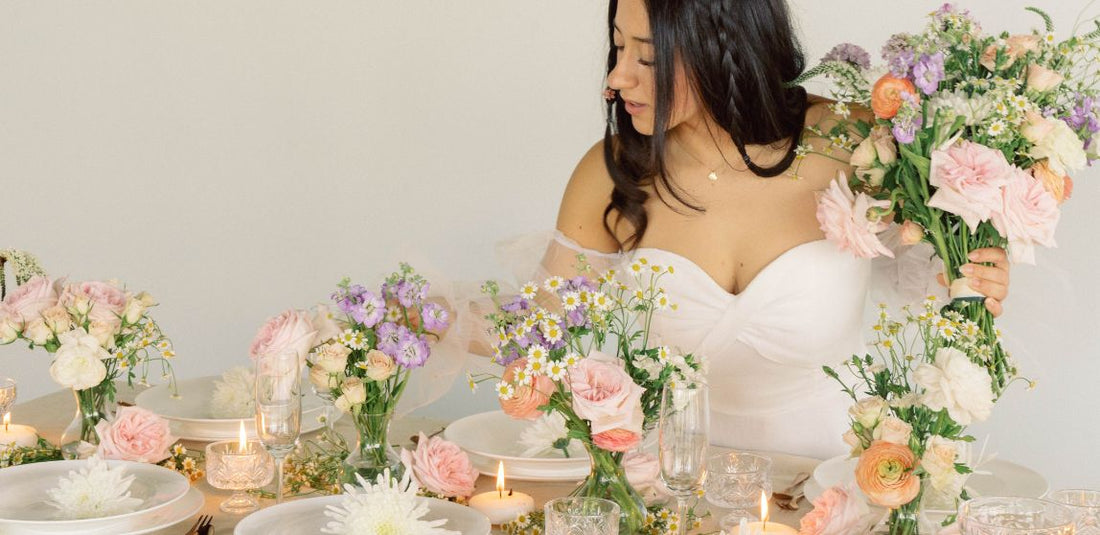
left=804, top=456, right=1051, bottom=514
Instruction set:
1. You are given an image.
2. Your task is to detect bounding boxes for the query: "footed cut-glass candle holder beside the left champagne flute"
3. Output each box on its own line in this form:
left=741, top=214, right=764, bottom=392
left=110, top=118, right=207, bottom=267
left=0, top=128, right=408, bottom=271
left=206, top=440, right=275, bottom=514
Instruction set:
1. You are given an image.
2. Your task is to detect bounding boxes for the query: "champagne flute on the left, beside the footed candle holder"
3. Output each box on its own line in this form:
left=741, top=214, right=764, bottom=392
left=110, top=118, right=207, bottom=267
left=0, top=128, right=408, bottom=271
left=256, top=352, right=301, bottom=503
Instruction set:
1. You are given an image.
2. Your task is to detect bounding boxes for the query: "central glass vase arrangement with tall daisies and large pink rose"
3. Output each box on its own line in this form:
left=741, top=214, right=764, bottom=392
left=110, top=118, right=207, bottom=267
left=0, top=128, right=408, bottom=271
left=470, top=258, right=701, bottom=533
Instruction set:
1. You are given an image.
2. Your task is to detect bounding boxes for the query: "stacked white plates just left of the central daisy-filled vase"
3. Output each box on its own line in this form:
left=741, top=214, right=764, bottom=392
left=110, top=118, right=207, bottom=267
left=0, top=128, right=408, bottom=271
left=443, top=411, right=590, bottom=481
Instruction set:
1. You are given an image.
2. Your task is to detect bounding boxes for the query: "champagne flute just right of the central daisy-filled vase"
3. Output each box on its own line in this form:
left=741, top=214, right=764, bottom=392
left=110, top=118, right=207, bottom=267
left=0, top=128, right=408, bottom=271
left=658, top=381, right=711, bottom=535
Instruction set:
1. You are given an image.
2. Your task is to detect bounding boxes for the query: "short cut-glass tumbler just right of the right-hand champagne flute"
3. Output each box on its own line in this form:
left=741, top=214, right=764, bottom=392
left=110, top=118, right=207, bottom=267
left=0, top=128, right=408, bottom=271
left=706, top=451, right=772, bottom=532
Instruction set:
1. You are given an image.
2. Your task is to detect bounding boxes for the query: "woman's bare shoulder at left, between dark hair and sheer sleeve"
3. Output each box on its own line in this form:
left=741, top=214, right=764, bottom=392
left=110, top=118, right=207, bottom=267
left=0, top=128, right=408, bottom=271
left=558, top=140, right=619, bottom=252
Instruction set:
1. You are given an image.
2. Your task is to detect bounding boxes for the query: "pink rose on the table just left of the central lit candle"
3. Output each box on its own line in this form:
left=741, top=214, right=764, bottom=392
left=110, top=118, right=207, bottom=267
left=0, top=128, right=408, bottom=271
left=402, top=433, right=479, bottom=498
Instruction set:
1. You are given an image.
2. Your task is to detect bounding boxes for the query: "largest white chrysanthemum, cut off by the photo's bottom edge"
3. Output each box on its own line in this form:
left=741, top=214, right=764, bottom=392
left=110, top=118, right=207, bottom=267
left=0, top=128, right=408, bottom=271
left=321, top=469, right=461, bottom=535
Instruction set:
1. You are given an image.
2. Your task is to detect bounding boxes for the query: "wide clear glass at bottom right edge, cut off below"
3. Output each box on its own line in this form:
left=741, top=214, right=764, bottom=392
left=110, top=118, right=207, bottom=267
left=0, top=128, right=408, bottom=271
left=959, top=498, right=1074, bottom=535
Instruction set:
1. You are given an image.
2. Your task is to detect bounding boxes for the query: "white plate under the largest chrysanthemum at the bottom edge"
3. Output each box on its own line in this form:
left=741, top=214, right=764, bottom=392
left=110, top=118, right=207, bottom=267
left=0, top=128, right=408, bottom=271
left=233, top=495, right=492, bottom=535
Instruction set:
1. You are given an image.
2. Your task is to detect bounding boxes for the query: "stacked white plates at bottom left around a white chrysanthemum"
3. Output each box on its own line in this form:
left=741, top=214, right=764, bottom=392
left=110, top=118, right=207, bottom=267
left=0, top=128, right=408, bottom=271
left=0, top=460, right=205, bottom=535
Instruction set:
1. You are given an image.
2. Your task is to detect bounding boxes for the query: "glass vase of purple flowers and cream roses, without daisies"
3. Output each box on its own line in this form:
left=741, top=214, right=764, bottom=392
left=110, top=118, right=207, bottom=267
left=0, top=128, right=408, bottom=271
left=308, top=264, right=450, bottom=481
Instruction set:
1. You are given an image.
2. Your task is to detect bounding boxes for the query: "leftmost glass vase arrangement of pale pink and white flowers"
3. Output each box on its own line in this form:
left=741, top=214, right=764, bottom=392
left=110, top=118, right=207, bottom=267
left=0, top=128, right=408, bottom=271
left=0, top=275, right=175, bottom=458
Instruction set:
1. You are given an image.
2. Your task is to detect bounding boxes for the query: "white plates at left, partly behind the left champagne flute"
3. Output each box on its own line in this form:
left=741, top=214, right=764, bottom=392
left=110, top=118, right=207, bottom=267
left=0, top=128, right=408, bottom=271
left=134, top=375, right=340, bottom=441
